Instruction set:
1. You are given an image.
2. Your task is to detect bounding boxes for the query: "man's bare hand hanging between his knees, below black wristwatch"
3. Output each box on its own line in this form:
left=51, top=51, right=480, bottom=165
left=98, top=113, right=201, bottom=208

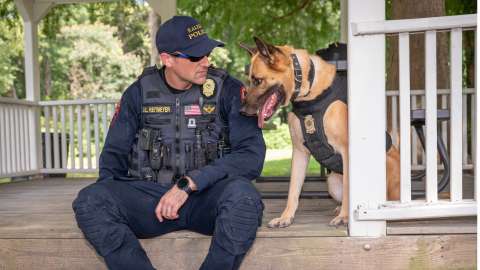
left=155, top=178, right=197, bottom=222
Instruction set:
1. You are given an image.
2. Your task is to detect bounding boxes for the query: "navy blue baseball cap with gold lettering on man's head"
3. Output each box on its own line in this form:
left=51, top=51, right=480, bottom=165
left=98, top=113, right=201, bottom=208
left=155, top=16, right=225, bottom=57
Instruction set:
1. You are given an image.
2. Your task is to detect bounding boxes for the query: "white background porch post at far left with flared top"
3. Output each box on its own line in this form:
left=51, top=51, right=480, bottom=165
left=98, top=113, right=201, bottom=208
left=15, top=0, right=54, bottom=173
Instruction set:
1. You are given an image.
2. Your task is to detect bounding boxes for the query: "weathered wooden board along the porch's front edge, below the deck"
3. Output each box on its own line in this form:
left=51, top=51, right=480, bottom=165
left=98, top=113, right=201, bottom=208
left=0, top=235, right=477, bottom=270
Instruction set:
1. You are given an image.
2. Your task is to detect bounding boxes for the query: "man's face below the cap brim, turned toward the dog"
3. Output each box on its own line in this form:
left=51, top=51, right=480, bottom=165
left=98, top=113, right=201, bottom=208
left=169, top=54, right=210, bottom=85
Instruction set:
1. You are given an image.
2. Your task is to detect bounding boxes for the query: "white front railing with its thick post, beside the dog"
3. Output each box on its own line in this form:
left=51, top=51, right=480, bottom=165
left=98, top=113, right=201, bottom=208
left=348, top=4, right=478, bottom=236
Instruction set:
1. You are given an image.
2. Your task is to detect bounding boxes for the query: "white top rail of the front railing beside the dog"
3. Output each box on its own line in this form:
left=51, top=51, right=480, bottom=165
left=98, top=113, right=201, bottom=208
left=352, top=14, right=477, bottom=36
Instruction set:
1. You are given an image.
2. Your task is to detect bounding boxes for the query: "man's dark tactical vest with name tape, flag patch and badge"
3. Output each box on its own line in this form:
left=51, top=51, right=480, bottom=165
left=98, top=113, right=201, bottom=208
left=128, top=67, right=230, bottom=184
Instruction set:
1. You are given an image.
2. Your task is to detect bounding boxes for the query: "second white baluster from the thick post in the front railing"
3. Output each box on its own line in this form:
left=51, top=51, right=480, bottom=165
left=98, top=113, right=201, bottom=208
left=425, top=31, right=438, bottom=202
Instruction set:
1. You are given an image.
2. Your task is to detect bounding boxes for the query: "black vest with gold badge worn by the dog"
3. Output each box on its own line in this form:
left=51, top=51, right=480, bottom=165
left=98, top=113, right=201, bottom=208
left=293, top=75, right=392, bottom=174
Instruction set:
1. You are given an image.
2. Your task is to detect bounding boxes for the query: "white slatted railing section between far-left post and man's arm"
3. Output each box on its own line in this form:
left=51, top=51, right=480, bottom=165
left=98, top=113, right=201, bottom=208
left=40, top=100, right=116, bottom=173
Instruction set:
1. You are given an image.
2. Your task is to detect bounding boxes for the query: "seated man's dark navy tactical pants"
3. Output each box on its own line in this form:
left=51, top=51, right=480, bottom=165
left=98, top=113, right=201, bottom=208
left=73, top=177, right=263, bottom=270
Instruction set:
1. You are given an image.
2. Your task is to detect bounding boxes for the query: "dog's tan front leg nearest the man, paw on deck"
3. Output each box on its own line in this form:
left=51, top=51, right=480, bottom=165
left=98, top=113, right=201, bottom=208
left=268, top=113, right=310, bottom=228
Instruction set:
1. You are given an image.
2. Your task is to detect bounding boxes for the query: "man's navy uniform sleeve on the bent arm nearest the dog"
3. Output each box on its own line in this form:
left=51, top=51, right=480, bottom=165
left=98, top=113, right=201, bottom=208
left=188, top=77, right=265, bottom=191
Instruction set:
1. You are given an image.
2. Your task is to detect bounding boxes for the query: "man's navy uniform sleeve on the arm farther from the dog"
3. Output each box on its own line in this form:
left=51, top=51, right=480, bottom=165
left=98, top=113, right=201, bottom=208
left=98, top=82, right=141, bottom=181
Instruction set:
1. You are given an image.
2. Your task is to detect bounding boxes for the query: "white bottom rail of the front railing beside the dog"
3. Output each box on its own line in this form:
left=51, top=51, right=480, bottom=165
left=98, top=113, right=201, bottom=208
left=355, top=200, right=477, bottom=220
